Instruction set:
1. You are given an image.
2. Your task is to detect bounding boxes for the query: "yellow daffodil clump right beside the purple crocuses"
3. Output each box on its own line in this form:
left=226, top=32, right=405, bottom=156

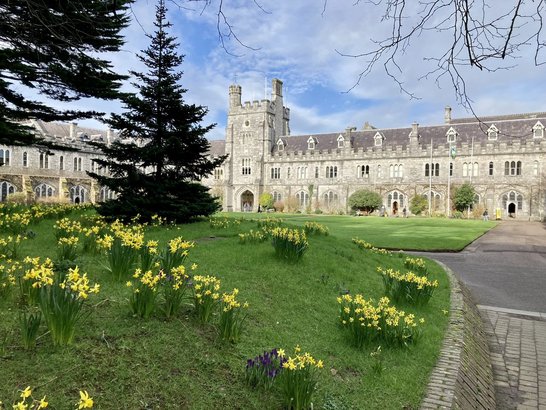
left=278, top=346, right=324, bottom=410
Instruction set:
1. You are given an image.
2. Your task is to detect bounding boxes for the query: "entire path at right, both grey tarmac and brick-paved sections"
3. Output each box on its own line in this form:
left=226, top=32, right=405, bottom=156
left=416, top=221, right=546, bottom=410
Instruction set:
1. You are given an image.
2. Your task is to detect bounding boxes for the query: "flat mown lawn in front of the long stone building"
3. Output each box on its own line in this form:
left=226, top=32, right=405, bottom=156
left=226, top=213, right=496, bottom=252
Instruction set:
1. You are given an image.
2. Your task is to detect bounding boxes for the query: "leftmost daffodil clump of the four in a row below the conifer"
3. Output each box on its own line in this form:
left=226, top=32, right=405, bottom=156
left=127, top=269, right=164, bottom=319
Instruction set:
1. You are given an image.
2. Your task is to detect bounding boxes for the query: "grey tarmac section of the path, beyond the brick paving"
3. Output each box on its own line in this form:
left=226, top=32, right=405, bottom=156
left=426, top=221, right=546, bottom=313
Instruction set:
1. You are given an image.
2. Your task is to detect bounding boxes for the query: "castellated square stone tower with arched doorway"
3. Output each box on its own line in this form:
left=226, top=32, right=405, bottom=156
left=225, top=79, right=290, bottom=211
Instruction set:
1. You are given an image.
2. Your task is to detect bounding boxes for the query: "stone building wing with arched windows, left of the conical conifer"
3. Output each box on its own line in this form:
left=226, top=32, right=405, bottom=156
left=0, top=120, right=116, bottom=203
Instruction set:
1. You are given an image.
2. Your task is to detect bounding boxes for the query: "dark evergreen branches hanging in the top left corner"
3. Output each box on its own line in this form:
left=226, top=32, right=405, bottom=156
left=0, top=0, right=132, bottom=145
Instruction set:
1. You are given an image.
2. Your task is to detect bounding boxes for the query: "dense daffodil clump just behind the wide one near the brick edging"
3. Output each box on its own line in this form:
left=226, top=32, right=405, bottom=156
left=377, top=267, right=438, bottom=305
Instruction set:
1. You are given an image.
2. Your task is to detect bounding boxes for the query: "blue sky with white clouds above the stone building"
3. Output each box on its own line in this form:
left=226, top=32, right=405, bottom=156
left=73, top=0, right=546, bottom=139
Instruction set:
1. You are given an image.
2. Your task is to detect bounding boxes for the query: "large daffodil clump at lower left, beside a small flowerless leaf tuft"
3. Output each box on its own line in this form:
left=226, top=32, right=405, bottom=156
left=36, top=266, right=100, bottom=346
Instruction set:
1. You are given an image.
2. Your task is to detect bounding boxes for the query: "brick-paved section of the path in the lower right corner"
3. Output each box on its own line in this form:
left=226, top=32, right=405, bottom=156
left=478, top=306, right=546, bottom=410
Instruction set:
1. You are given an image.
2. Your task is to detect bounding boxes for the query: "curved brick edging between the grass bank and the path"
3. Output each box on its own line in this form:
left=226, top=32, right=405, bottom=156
left=421, top=261, right=496, bottom=410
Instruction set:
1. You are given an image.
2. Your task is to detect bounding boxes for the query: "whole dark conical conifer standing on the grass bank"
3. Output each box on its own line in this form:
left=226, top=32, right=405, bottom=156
left=89, top=0, right=225, bottom=222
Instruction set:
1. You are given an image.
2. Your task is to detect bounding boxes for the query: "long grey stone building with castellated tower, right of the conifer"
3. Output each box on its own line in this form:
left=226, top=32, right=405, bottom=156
left=204, top=79, right=546, bottom=220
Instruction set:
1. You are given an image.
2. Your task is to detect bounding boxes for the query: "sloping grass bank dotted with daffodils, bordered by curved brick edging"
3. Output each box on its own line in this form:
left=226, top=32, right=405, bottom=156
left=0, top=211, right=454, bottom=409
